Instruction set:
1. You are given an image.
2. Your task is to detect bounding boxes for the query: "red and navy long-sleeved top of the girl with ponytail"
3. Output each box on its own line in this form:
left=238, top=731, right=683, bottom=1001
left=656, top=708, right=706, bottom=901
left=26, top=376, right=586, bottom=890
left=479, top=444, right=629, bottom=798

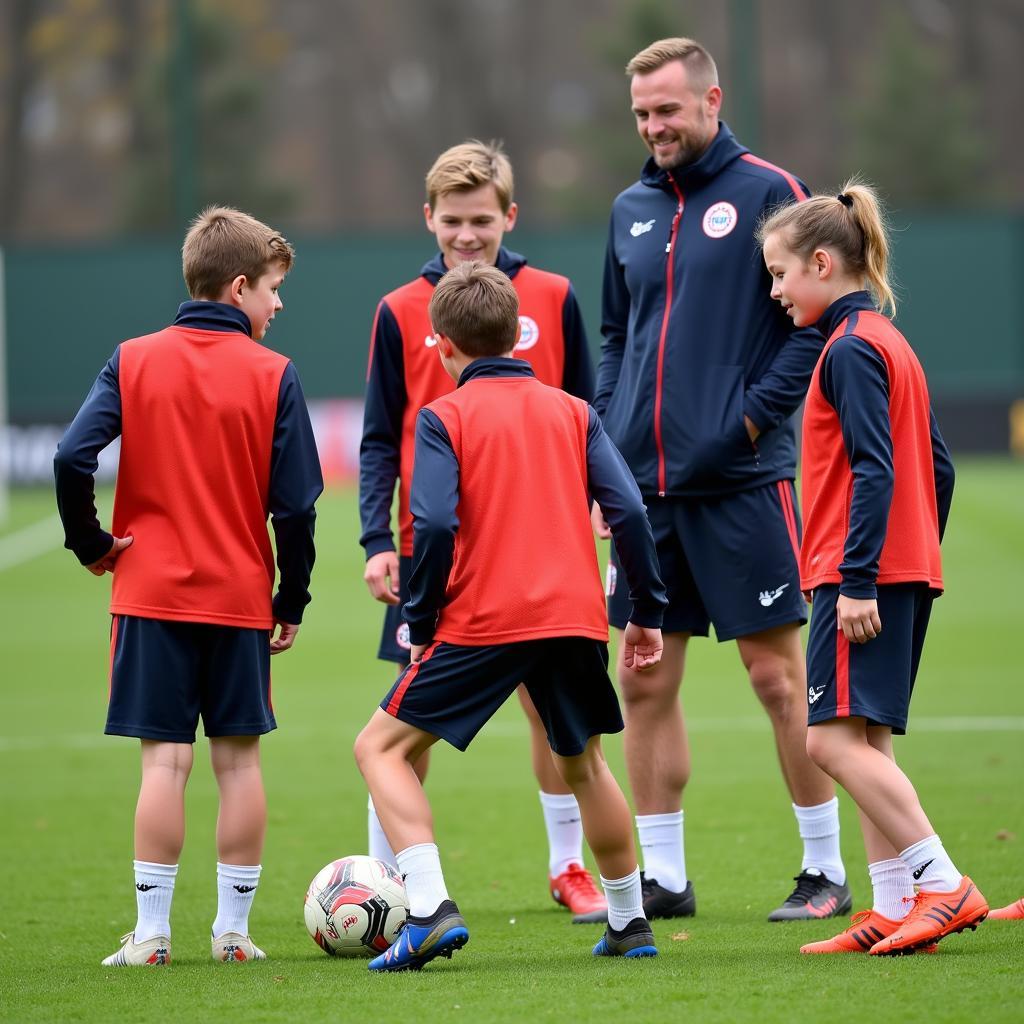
left=801, top=292, right=953, bottom=598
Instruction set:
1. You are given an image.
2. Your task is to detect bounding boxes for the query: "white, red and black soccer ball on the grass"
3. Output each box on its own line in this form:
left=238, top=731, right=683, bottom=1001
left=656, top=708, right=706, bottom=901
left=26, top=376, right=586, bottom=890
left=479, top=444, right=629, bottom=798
left=303, top=856, right=409, bottom=956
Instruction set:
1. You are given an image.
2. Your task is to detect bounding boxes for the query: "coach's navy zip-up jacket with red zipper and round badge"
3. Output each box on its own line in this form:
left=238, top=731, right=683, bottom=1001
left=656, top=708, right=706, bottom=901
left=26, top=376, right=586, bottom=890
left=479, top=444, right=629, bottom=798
left=594, top=123, right=823, bottom=496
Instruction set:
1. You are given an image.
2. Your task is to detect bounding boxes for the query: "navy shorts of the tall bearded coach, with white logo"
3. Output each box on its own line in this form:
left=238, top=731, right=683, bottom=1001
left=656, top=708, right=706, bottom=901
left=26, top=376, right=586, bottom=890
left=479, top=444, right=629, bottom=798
left=605, top=480, right=807, bottom=640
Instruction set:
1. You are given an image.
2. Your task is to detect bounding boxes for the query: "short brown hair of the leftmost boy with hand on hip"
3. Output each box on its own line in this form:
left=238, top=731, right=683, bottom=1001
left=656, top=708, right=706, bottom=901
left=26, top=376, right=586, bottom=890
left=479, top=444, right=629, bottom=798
left=181, top=206, right=295, bottom=299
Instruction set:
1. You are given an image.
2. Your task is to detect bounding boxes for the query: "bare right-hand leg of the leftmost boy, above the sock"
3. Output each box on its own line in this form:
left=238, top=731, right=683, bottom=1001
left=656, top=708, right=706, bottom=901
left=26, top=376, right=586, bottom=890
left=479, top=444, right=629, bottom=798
left=210, top=736, right=266, bottom=864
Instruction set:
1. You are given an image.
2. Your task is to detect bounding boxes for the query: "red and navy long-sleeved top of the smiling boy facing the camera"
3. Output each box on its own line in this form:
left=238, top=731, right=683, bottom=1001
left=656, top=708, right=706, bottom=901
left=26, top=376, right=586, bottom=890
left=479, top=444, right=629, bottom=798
left=359, top=248, right=594, bottom=558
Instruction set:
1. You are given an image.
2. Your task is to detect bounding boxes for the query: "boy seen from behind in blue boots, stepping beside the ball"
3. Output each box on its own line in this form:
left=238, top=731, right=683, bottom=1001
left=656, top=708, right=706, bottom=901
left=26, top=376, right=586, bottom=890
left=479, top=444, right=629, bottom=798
left=355, top=261, right=666, bottom=971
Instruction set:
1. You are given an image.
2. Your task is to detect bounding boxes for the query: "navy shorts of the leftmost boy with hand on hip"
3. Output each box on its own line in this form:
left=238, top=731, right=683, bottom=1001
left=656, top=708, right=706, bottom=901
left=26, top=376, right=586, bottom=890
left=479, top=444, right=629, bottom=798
left=103, top=615, right=278, bottom=743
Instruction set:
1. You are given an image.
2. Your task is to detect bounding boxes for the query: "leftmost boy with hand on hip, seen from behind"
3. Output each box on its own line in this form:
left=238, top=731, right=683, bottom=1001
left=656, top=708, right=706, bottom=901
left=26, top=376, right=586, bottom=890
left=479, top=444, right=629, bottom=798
left=54, top=207, right=323, bottom=967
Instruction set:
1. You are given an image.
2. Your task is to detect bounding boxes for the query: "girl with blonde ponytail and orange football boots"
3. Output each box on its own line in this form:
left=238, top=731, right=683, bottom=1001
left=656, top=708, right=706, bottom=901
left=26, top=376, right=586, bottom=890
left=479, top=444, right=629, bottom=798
left=758, top=180, right=988, bottom=955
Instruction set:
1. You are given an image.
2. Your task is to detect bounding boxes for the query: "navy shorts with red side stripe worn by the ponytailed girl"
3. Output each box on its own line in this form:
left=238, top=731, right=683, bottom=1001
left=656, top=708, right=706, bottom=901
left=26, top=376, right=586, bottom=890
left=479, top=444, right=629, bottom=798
left=807, top=583, right=935, bottom=735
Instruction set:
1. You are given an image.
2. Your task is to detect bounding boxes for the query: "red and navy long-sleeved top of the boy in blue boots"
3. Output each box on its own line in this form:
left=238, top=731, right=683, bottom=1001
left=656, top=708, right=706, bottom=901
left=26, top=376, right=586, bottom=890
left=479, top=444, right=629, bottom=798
left=404, top=358, right=666, bottom=646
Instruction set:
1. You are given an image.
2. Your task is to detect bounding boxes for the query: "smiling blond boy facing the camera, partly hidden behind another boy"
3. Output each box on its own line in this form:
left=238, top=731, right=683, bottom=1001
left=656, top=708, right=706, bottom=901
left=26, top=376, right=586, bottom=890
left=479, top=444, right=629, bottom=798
left=359, top=139, right=606, bottom=923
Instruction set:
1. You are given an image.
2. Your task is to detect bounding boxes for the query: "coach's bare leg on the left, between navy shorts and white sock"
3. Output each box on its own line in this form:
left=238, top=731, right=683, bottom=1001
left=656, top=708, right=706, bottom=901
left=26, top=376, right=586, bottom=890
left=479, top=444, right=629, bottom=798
left=614, top=630, right=690, bottom=811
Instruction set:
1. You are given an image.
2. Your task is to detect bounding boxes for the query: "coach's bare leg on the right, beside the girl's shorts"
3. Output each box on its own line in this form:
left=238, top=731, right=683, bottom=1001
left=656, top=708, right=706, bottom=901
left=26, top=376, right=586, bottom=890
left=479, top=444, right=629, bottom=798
left=736, top=623, right=836, bottom=807
